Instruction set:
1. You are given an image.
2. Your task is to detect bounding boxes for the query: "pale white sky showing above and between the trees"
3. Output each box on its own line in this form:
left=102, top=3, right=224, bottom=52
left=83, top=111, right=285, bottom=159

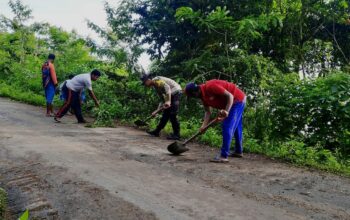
left=0, top=0, right=150, bottom=69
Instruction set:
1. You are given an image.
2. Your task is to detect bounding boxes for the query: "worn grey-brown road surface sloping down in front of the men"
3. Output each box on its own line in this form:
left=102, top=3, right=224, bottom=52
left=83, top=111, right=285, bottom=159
left=0, top=99, right=350, bottom=220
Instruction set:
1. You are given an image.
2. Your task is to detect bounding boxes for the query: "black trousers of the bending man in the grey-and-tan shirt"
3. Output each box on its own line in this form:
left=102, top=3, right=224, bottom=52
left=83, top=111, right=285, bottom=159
left=156, top=93, right=181, bottom=136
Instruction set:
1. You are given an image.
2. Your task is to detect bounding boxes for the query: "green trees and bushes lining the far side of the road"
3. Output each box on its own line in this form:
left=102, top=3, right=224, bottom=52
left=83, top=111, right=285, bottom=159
left=0, top=0, right=350, bottom=175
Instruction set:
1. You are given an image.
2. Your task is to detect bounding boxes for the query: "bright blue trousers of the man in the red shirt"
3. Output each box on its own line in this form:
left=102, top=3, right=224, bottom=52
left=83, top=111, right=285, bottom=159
left=221, top=101, right=245, bottom=158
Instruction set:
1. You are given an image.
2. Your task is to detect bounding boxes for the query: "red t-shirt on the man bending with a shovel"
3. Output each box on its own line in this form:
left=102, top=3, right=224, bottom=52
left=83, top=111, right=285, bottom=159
left=199, top=79, right=245, bottom=109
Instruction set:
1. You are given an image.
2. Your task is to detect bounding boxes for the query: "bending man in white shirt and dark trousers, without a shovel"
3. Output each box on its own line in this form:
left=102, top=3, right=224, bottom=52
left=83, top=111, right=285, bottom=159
left=54, top=70, right=101, bottom=123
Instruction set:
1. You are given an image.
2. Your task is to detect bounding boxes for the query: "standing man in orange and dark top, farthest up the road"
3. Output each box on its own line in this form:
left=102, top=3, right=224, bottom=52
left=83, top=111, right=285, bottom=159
left=41, top=54, right=58, bottom=117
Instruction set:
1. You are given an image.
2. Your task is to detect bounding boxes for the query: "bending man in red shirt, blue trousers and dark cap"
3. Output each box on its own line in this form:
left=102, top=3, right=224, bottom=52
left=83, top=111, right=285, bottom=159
left=185, top=80, right=246, bottom=163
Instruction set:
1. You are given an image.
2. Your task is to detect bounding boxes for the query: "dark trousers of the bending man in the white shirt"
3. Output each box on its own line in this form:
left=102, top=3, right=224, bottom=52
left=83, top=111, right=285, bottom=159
left=56, top=85, right=84, bottom=122
